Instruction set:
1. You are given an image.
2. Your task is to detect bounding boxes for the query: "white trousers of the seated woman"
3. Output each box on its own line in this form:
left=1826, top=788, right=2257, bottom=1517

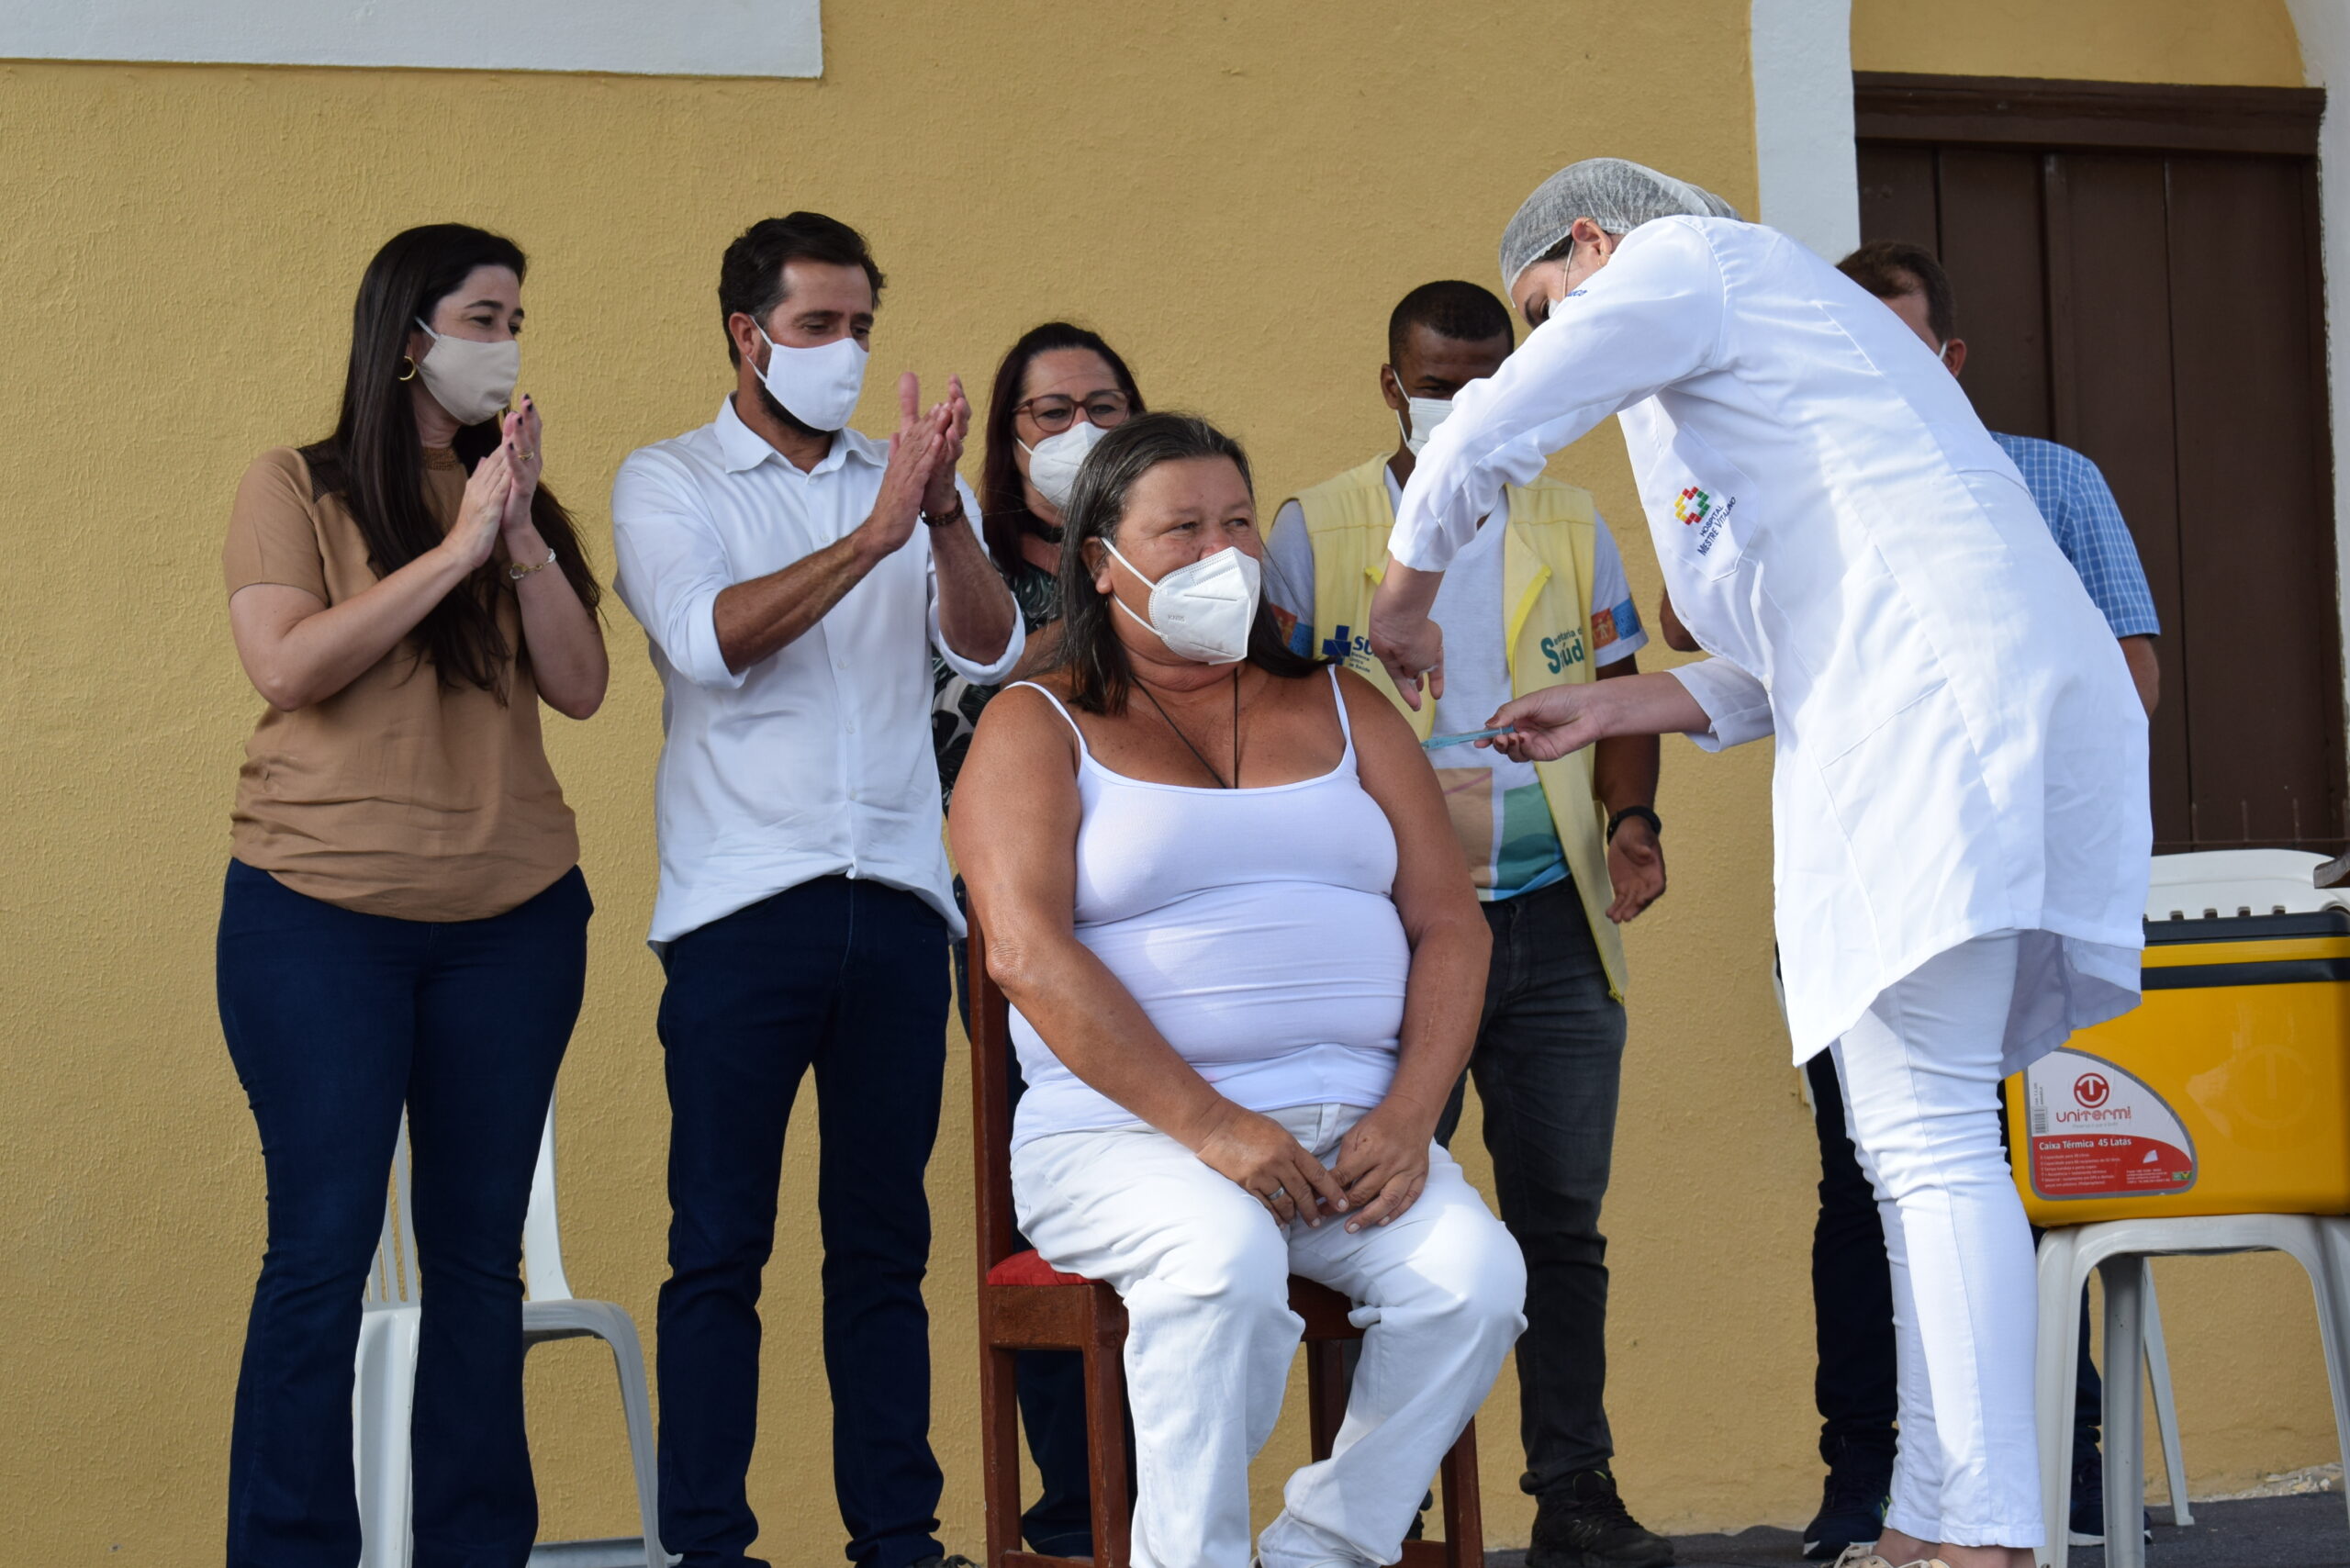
left=1013, top=1105, right=1525, bottom=1568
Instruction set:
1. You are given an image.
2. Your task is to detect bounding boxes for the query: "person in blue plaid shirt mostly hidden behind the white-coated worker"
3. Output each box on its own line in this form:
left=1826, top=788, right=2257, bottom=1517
left=1748, top=240, right=2162, bottom=1561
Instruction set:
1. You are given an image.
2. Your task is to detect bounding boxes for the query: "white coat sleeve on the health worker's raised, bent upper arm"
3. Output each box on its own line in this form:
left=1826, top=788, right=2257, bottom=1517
left=1386, top=218, right=1728, bottom=571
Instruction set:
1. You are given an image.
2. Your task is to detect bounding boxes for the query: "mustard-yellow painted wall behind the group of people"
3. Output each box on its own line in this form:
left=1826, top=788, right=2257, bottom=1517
left=0, top=0, right=2326, bottom=1565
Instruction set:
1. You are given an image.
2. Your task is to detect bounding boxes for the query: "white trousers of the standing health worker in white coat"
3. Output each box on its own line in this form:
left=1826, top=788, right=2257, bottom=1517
left=1833, top=931, right=2044, bottom=1547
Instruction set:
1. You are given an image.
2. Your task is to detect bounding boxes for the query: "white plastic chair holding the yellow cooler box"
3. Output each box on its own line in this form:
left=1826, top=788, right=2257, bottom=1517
left=2035, top=848, right=2350, bottom=1568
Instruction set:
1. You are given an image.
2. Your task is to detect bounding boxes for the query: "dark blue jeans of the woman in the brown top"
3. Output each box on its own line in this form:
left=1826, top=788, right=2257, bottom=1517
left=218, top=860, right=595, bottom=1568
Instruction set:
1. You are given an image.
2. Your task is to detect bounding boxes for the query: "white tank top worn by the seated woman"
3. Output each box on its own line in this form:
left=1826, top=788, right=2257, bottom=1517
left=1011, top=667, right=1413, bottom=1149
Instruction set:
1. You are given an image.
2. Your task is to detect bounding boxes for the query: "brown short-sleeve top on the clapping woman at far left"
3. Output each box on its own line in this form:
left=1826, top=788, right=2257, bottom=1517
left=221, top=447, right=580, bottom=922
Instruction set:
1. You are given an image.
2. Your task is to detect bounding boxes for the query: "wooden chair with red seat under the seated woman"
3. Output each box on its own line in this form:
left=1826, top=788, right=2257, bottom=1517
left=970, top=919, right=1485, bottom=1568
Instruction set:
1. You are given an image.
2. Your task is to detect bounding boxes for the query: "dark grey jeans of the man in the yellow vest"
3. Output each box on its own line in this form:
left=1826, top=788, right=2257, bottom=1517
left=1436, top=884, right=1624, bottom=1495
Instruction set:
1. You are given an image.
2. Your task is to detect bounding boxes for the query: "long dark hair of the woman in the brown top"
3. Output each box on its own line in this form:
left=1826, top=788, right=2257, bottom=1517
left=303, top=223, right=601, bottom=700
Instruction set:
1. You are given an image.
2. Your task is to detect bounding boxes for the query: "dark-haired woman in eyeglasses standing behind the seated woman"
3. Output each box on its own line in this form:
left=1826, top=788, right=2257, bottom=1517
left=931, top=322, right=1142, bottom=1556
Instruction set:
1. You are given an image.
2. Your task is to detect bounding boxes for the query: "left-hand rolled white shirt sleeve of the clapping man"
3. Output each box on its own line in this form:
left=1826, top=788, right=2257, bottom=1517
left=611, top=452, right=743, bottom=691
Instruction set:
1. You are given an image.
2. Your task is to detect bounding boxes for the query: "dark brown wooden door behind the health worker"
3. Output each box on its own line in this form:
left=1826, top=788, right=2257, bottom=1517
left=1856, top=75, right=2350, bottom=854
